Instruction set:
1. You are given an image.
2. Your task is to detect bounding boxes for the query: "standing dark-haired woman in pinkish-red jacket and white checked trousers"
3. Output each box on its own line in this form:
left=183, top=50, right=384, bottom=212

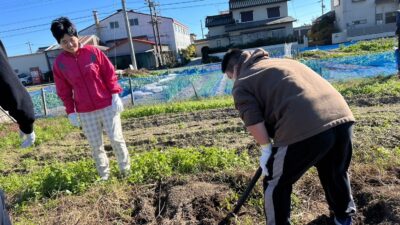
left=51, top=17, right=130, bottom=180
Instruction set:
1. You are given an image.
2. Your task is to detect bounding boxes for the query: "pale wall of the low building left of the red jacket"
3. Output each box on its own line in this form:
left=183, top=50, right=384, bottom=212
left=8, top=53, right=49, bottom=74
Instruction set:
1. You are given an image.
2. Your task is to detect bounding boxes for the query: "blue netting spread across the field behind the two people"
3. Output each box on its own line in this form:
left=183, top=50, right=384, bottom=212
left=30, top=52, right=397, bottom=117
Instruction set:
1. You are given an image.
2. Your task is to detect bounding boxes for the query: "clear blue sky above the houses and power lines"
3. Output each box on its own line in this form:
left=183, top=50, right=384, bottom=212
left=0, top=0, right=330, bottom=56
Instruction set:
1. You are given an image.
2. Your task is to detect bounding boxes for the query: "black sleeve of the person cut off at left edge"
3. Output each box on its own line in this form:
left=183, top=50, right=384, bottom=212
left=0, top=41, right=35, bottom=134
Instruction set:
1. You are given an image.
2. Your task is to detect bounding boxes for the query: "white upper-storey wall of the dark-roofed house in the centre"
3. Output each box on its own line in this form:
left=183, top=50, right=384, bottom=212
left=232, top=3, right=288, bottom=23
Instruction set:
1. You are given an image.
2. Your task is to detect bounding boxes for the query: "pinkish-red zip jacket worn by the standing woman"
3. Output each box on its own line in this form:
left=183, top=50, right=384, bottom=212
left=53, top=45, right=122, bottom=114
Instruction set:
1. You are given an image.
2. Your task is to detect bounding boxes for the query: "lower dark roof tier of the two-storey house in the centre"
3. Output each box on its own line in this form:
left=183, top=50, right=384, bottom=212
left=225, top=16, right=296, bottom=32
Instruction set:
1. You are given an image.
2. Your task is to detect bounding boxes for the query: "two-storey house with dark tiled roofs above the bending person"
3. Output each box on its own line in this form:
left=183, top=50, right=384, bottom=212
left=203, top=0, right=296, bottom=48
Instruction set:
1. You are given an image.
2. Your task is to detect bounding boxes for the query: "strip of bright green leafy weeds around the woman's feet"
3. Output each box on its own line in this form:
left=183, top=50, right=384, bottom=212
left=0, top=147, right=249, bottom=206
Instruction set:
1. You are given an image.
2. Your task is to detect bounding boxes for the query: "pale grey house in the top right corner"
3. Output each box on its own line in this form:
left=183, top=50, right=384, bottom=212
left=331, top=0, right=399, bottom=43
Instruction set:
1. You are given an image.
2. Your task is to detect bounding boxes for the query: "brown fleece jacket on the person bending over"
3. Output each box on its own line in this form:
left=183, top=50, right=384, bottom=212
left=232, top=49, right=354, bottom=147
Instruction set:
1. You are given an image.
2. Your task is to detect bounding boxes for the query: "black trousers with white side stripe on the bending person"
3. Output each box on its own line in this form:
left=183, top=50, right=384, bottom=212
left=264, top=122, right=356, bottom=225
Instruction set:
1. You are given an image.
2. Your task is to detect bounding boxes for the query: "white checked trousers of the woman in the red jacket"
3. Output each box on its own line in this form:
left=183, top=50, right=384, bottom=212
left=79, top=106, right=130, bottom=177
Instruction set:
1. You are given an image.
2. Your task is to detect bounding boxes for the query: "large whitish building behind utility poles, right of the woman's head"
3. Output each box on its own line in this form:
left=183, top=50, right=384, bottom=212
left=79, top=10, right=191, bottom=60
